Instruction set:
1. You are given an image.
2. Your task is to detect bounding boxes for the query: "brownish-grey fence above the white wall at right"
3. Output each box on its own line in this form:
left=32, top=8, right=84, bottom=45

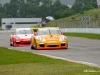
left=56, top=19, right=100, bottom=28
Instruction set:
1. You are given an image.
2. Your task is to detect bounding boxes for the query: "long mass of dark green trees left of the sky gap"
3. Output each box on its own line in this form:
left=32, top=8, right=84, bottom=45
left=0, top=0, right=77, bottom=19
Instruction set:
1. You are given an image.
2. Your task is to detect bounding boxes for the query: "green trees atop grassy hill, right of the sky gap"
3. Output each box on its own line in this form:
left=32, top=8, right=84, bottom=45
left=72, top=0, right=97, bottom=13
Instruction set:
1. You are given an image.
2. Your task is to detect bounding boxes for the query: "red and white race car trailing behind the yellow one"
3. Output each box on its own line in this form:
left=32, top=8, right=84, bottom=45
left=10, top=28, right=34, bottom=46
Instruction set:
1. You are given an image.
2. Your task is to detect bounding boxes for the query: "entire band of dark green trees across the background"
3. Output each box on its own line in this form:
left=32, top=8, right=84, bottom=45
left=0, top=0, right=98, bottom=25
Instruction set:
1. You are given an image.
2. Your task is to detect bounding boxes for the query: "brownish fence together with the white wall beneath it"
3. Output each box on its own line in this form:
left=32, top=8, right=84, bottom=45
left=56, top=19, right=100, bottom=34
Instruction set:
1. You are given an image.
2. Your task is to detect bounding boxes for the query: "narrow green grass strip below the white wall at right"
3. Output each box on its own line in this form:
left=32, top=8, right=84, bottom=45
left=65, top=33, right=100, bottom=39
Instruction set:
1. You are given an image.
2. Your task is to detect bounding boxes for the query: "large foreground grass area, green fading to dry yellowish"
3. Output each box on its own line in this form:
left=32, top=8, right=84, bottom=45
left=0, top=47, right=100, bottom=75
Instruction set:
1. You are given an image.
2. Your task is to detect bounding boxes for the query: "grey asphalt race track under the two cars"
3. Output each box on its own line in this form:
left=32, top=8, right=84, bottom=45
left=0, top=33, right=100, bottom=67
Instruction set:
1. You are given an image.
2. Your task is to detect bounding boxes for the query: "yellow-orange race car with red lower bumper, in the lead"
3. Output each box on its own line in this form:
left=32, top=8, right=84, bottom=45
left=31, top=27, right=68, bottom=50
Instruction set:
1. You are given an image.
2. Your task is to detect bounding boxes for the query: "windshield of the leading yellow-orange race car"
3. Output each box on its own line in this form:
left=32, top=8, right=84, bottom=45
left=38, top=29, right=61, bottom=35
